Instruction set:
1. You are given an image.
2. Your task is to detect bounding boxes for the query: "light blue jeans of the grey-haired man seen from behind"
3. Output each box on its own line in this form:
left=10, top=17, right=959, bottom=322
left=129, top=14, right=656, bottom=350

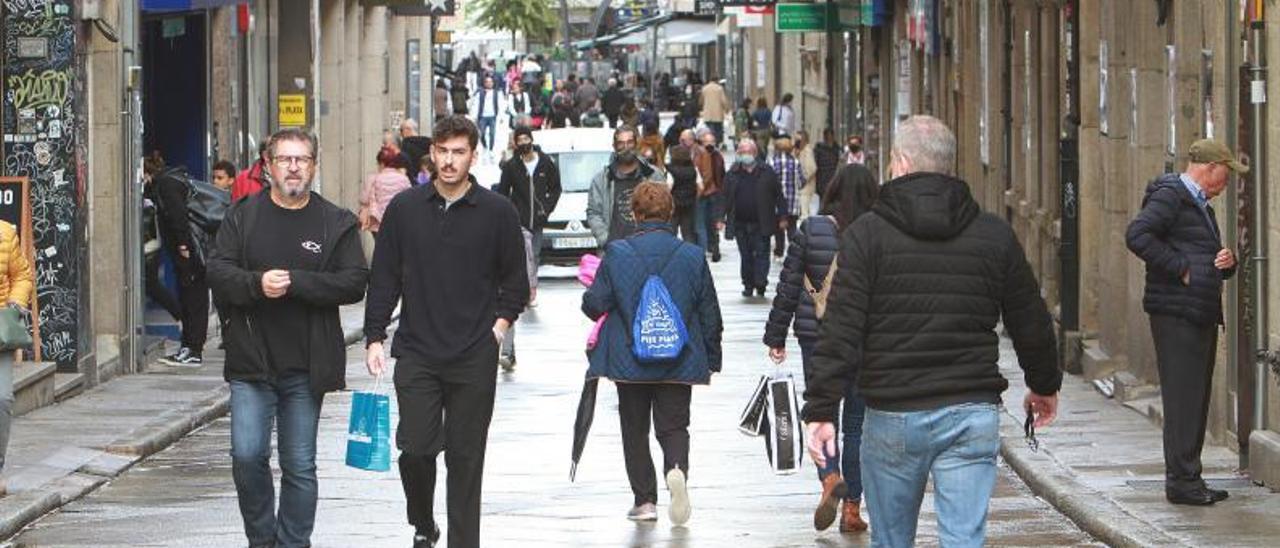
left=863, top=403, right=1000, bottom=548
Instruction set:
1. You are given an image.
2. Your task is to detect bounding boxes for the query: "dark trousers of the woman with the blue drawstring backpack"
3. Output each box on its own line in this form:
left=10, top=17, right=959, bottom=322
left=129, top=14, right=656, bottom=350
left=617, top=383, right=694, bottom=506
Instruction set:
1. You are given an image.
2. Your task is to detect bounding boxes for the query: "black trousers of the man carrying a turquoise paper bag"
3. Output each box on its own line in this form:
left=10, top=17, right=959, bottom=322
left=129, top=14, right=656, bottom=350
left=396, top=339, right=498, bottom=548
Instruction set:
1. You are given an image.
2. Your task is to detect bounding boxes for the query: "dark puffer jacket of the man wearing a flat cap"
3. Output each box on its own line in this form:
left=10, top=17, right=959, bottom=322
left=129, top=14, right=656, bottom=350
left=1125, top=174, right=1235, bottom=325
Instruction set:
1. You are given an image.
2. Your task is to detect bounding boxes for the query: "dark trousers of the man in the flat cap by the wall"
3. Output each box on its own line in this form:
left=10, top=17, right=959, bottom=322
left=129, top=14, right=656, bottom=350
left=1151, top=314, right=1217, bottom=490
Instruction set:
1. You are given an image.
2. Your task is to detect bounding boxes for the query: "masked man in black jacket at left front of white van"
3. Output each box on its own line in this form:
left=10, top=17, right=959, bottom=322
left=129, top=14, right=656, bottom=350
left=494, top=128, right=561, bottom=371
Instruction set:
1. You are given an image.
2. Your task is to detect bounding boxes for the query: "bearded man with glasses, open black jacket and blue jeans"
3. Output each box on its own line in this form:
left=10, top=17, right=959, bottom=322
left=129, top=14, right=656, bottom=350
left=209, top=129, right=369, bottom=548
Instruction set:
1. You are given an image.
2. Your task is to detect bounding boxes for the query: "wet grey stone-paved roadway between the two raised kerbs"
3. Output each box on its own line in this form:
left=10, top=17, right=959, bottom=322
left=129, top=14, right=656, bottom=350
left=12, top=242, right=1097, bottom=548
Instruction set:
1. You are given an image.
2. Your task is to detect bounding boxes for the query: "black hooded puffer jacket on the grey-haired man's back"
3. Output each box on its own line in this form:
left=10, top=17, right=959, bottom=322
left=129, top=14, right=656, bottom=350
left=804, top=173, right=1062, bottom=421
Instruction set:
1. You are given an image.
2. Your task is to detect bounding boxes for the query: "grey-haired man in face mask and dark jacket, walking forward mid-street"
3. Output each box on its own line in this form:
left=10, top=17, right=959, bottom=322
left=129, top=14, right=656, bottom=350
left=723, top=140, right=787, bottom=297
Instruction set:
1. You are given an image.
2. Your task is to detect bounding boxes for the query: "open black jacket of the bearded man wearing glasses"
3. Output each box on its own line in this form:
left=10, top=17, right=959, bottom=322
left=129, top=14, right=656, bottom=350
left=209, top=192, right=369, bottom=396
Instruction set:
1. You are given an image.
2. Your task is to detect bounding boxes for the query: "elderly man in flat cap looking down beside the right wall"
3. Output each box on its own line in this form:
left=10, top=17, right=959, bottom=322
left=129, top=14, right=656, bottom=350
left=1125, top=140, right=1249, bottom=506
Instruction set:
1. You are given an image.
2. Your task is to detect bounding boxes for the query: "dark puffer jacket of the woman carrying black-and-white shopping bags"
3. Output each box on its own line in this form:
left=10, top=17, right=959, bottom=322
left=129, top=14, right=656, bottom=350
left=764, top=215, right=840, bottom=348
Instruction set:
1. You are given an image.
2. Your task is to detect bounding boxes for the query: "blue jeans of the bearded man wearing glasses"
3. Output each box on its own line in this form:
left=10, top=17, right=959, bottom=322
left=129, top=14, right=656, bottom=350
left=230, top=373, right=321, bottom=548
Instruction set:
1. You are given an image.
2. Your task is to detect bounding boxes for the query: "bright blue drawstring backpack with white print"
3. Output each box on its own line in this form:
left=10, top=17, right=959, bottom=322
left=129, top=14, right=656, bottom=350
left=627, top=242, right=689, bottom=364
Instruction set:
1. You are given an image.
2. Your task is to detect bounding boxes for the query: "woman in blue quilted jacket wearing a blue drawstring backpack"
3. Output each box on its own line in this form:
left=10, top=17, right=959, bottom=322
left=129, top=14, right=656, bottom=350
left=582, top=182, right=723, bottom=525
